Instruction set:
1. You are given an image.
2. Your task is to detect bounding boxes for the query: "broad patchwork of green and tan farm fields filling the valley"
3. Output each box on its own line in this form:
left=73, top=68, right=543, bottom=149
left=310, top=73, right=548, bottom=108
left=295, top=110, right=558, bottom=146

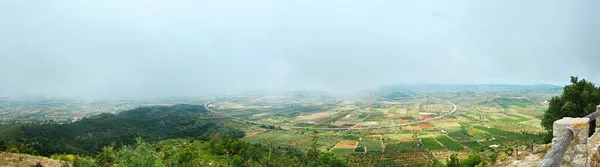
left=205, top=90, right=557, bottom=166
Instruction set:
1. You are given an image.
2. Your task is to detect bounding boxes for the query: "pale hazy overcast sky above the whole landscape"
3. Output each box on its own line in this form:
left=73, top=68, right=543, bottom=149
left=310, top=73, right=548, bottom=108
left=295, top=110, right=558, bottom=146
left=0, top=0, right=600, bottom=96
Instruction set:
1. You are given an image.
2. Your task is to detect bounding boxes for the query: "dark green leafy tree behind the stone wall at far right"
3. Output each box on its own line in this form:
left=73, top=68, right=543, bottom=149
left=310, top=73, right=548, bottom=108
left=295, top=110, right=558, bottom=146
left=541, top=76, right=600, bottom=142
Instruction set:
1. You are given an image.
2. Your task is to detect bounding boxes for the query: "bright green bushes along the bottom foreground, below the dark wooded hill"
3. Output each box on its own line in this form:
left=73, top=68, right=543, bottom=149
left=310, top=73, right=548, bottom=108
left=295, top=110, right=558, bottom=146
left=51, top=134, right=346, bottom=167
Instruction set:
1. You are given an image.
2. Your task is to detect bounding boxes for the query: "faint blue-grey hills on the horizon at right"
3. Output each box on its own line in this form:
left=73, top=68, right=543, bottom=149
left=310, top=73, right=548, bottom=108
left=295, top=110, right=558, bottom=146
left=381, top=84, right=562, bottom=92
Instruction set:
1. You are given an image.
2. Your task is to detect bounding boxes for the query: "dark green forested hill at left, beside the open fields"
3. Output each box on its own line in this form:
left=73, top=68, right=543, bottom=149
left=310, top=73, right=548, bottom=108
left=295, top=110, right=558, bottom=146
left=0, top=105, right=244, bottom=156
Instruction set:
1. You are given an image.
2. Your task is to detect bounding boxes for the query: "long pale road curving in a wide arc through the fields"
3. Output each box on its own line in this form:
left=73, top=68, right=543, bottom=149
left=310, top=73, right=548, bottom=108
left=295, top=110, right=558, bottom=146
left=204, top=98, right=458, bottom=130
